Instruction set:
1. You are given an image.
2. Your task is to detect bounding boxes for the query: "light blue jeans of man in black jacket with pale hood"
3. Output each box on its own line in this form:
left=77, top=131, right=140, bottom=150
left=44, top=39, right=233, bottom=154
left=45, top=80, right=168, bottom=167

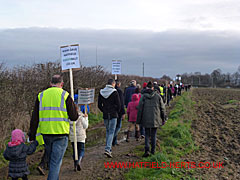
left=104, top=118, right=117, bottom=152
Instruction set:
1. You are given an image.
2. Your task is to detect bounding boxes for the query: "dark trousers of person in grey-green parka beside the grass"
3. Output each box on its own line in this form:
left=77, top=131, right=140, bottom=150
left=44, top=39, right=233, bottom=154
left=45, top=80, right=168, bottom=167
left=145, top=128, right=157, bottom=154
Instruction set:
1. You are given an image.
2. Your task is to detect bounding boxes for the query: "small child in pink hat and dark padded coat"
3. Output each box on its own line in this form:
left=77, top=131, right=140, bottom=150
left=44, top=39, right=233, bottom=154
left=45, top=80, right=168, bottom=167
left=3, top=129, right=38, bottom=180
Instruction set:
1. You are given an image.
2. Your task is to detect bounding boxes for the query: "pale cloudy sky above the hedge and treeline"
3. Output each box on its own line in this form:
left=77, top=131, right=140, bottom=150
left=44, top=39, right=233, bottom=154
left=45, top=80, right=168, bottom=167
left=0, top=0, right=240, bottom=77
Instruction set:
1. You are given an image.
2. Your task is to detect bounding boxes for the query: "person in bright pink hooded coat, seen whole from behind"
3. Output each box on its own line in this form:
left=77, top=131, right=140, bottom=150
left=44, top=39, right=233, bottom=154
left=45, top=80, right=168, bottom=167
left=126, top=94, right=140, bottom=142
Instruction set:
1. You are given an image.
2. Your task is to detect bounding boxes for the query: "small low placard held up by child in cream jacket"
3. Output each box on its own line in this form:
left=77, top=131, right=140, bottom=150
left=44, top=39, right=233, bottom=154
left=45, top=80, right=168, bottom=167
left=78, top=89, right=95, bottom=104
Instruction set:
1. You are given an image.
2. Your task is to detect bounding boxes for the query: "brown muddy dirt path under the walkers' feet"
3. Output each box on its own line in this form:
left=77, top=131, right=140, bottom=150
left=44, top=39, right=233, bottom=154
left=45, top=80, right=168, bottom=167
left=30, top=125, right=144, bottom=180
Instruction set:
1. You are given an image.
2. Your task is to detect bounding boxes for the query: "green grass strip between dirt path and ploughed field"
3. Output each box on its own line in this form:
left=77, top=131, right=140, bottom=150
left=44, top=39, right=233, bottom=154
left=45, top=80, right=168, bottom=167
left=125, top=92, right=198, bottom=180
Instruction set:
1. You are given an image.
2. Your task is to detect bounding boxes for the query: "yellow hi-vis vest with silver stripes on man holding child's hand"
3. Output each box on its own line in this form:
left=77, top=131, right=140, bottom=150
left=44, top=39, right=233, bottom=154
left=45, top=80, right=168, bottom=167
left=38, top=87, right=70, bottom=134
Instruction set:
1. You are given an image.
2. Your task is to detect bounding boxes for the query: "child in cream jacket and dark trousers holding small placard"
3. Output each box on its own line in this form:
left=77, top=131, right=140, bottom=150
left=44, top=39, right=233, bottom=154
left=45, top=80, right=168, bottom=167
left=69, top=111, right=88, bottom=171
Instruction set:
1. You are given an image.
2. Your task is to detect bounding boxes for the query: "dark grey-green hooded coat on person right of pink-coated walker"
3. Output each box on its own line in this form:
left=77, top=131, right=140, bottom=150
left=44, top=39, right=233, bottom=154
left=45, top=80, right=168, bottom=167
left=137, top=89, right=166, bottom=128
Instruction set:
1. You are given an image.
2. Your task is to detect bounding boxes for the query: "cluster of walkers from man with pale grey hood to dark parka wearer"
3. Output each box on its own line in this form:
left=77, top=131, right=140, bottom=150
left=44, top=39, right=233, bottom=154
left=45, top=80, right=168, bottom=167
left=98, top=79, right=167, bottom=158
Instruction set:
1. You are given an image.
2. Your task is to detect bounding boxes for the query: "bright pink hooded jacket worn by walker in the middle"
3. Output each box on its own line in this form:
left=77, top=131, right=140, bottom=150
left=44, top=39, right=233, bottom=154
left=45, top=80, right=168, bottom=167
left=127, top=94, right=139, bottom=122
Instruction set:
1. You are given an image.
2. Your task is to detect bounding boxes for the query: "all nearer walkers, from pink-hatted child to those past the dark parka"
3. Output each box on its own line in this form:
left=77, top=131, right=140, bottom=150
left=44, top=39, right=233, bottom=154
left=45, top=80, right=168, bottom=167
left=4, top=75, right=188, bottom=180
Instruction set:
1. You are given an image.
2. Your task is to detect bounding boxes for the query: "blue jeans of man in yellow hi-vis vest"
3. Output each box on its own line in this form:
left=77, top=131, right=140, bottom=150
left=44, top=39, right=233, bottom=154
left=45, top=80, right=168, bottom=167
left=43, top=135, right=68, bottom=180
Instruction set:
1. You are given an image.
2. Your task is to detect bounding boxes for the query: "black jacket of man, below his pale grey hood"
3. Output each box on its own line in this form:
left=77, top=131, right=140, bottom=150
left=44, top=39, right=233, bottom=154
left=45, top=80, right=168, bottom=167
left=98, top=91, right=121, bottom=120
